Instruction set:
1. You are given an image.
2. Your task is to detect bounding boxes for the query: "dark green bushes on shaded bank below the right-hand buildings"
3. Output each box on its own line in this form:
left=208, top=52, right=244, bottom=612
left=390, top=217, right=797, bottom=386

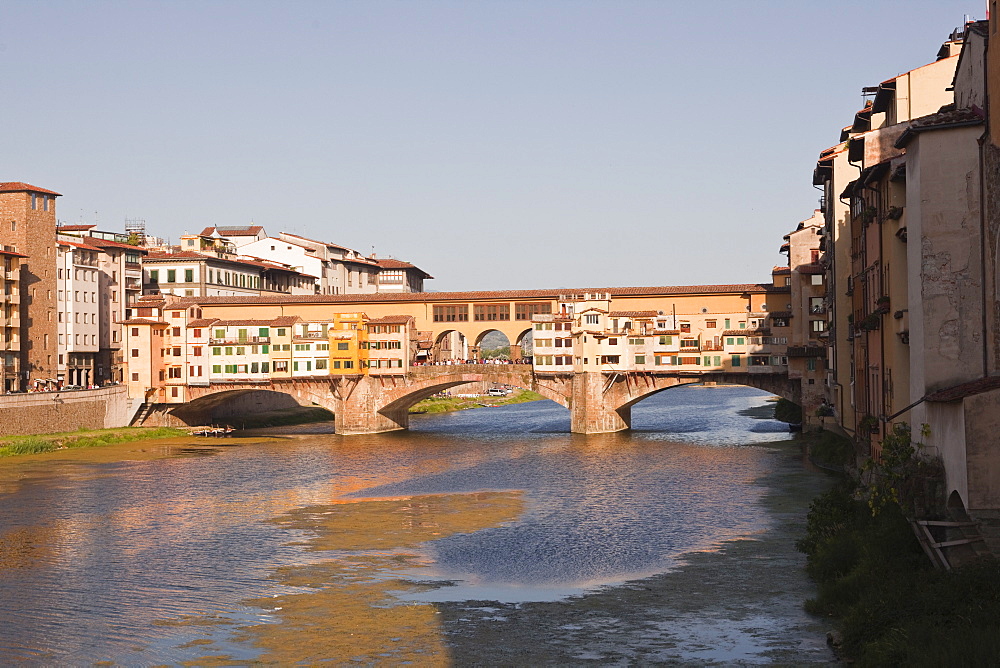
left=797, top=454, right=1000, bottom=666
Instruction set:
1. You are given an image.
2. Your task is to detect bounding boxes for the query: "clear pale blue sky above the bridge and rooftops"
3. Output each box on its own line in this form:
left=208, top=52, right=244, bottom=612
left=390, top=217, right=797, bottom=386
left=0, top=0, right=985, bottom=290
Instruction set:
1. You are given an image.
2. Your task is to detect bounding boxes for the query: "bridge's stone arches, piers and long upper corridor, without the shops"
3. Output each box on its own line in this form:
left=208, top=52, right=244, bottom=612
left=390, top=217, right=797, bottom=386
left=133, top=284, right=799, bottom=434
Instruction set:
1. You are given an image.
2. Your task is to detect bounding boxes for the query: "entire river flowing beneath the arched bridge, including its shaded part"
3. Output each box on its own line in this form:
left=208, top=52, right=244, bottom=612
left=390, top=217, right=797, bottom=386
left=0, top=387, right=833, bottom=665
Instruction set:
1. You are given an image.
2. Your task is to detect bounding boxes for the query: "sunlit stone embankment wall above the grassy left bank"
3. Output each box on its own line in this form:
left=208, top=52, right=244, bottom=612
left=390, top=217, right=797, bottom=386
left=0, top=385, right=132, bottom=436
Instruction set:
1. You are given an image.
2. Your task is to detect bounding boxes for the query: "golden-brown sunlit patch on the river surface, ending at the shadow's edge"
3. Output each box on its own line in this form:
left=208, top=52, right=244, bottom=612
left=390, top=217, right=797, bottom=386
left=249, top=492, right=524, bottom=666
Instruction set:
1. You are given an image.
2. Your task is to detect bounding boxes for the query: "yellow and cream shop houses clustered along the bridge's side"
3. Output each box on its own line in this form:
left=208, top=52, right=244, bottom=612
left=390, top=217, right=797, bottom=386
left=122, top=293, right=787, bottom=403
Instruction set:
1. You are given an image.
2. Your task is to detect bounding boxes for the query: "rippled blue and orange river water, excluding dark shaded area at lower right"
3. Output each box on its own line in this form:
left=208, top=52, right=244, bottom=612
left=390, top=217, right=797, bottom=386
left=0, top=387, right=828, bottom=664
